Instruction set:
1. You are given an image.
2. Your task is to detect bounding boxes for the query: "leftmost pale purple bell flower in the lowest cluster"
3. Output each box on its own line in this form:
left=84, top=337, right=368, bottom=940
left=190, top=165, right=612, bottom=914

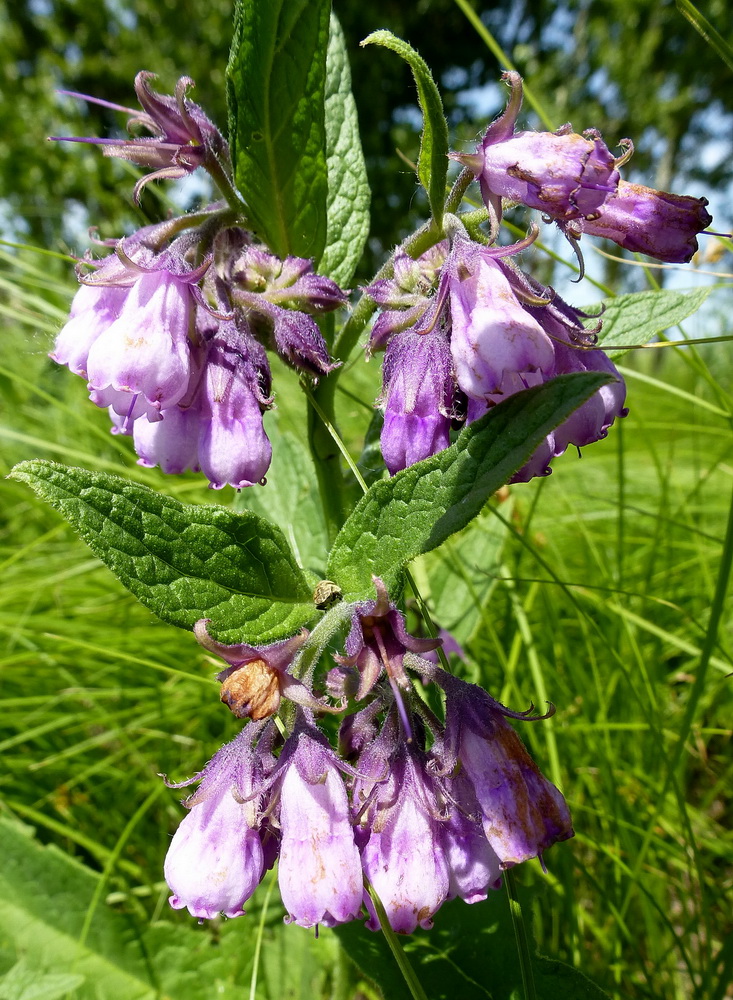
left=164, top=726, right=266, bottom=919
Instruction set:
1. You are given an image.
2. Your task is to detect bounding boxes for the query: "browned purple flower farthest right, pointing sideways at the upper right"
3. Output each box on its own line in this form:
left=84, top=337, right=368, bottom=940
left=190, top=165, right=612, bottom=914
left=567, top=181, right=713, bottom=264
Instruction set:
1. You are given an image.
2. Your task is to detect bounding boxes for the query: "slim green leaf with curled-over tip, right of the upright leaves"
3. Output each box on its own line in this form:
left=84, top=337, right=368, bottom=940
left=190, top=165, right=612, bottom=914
left=361, top=29, right=448, bottom=228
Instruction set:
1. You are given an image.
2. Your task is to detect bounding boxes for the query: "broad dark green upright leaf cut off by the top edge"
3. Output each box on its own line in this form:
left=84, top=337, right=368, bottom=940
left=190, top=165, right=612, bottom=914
left=227, top=0, right=331, bottom=261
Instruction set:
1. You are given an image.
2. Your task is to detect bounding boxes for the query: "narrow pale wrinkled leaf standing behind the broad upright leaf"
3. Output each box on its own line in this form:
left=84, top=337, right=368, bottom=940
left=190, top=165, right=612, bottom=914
left=319, top=14, right=369, bottom=287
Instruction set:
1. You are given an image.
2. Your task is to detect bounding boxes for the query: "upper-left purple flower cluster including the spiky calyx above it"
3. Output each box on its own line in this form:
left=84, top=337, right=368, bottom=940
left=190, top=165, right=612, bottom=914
left=51, top=73, right=346, bottom=489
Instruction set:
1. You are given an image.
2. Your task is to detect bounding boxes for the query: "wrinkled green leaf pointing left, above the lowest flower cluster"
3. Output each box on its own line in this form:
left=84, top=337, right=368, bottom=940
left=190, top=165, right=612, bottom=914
left=12, top=461, right=315, bottom=643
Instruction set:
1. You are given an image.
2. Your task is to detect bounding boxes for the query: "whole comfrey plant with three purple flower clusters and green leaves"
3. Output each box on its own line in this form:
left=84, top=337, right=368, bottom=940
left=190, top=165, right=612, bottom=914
left=15, top=0, right=710, bottom=992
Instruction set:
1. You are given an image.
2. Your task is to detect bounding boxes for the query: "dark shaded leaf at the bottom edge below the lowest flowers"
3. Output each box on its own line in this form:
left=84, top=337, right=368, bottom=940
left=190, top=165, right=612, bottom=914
left=336, top=891, right=608, bottom=1000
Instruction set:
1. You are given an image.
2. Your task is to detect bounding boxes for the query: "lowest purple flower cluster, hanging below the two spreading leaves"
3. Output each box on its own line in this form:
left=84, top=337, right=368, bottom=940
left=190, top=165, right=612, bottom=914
left=165, top=578, right=573, bottom=933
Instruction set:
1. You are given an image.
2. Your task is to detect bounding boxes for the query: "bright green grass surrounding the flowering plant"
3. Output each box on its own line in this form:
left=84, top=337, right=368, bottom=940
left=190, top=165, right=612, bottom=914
left=0, top=244, right=733, bottom=1000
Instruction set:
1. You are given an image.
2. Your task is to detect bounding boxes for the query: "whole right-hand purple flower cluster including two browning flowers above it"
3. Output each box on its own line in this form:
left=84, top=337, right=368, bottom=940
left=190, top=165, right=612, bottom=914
left=366, top=66, right=711, bottom=482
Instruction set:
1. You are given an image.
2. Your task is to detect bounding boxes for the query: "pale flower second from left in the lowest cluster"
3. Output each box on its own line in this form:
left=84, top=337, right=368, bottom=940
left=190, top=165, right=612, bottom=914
left=277, top=714, right=363, bottom=927
